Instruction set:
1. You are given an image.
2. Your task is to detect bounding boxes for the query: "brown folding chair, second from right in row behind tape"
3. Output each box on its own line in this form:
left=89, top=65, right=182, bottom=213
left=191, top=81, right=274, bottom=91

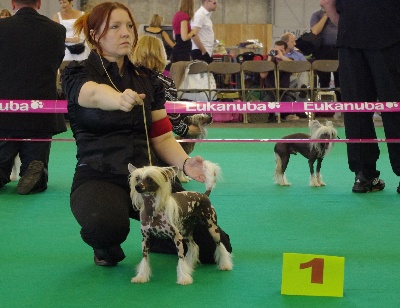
left=276, top=61, right=313, bottom=123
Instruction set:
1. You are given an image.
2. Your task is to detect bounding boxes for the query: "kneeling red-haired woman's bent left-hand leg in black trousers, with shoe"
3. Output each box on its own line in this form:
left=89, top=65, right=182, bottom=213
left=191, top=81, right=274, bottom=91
left=71, top=180, right=132, bottom=265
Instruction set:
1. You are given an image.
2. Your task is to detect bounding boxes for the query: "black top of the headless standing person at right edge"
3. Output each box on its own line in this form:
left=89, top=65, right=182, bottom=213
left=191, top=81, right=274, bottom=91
left=336, top=0, right=400, bottom=49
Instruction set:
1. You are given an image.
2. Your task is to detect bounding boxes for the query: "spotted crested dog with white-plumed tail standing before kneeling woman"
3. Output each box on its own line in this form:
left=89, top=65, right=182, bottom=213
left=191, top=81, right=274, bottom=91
left=128, top=161, right=233, bottom=285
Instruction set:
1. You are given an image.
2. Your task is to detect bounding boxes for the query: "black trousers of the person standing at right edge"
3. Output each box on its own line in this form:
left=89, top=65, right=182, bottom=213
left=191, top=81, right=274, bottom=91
left=339, top=42, right=400, bottom=178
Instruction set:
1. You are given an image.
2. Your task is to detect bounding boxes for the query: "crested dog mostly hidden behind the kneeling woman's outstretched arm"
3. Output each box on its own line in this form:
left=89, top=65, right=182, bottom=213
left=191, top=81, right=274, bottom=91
left=175, top=113, right=212, bottom=183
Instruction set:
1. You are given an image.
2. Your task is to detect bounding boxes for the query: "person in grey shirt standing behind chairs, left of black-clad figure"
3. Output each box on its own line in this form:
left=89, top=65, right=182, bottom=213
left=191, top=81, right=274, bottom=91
left=310, top=8, right=340, bottom=89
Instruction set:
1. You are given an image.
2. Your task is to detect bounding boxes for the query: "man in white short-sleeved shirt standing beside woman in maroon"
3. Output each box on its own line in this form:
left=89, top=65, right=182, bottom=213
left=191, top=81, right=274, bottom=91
left=191, top=0, right=218, bottom=63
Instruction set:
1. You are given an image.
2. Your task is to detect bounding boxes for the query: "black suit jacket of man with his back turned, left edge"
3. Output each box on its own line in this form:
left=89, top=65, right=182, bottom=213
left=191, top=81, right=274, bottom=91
left=0, top=7, right=66, bottom=134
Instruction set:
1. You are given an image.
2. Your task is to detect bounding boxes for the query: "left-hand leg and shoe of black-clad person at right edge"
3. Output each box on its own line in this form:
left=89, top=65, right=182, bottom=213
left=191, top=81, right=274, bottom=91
left=339, top=48, right=384, bottom=192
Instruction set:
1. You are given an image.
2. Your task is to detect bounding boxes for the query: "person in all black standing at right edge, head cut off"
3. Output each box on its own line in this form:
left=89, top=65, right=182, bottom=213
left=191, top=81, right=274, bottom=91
left=320, top=0, right=400, bottom=193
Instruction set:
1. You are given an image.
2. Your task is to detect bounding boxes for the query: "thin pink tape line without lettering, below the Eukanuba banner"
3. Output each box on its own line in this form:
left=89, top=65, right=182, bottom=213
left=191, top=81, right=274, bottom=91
left=0, top=138, right=400, bottom=143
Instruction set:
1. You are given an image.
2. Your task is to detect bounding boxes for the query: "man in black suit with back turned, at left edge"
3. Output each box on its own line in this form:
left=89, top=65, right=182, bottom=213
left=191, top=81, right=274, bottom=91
left=0, top=0, right=66, bottom=195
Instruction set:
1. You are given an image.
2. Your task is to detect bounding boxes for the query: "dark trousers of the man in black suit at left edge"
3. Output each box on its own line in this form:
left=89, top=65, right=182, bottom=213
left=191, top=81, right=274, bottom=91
left=0, top=131, right=52, bottom=186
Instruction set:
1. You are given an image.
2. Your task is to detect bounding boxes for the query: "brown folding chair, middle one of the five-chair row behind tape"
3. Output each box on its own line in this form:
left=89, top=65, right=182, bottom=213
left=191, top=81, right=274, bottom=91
left=240, top=61, right=276, bottom=123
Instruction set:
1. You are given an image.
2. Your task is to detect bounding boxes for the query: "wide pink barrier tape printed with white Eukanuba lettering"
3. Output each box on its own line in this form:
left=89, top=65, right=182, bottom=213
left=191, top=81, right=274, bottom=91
left=0, top=99, right=400, bottom=113
